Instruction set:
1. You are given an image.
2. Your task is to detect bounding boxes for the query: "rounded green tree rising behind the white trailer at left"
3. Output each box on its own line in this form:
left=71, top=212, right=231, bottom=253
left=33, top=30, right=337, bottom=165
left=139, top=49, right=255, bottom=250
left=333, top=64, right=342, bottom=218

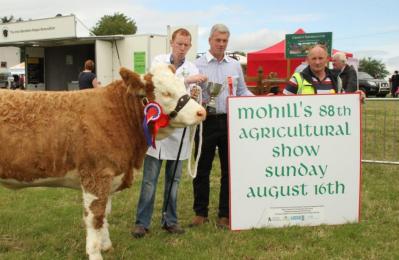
left=92, top=13, right=137, bottom=35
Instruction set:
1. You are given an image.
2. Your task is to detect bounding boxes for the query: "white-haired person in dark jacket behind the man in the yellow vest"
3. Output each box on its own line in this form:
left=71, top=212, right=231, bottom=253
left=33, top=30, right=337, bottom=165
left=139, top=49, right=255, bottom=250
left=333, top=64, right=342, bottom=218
left=332, top=52, right=358, bottom=93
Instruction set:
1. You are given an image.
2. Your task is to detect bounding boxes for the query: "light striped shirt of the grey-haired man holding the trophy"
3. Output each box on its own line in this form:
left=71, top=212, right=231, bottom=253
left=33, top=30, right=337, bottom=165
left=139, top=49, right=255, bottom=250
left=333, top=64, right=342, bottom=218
left=194, top=51, right=253, bottom=114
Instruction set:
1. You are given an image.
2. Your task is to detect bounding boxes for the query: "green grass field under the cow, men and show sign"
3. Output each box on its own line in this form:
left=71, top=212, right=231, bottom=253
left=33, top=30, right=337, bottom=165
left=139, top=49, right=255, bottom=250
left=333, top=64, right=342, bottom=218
left=0, top=98, right=399, bottom=260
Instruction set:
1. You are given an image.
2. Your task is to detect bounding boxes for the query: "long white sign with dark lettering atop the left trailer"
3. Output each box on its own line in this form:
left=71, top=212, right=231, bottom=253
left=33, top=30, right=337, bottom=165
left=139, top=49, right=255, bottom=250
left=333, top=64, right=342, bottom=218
left=0, top=15, right=76, bottom=43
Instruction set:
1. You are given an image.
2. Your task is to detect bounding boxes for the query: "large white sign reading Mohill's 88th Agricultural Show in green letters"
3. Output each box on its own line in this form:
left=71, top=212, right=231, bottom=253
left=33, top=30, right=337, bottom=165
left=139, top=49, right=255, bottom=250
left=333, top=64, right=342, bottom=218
left=228, top=94, right=361, bottom=230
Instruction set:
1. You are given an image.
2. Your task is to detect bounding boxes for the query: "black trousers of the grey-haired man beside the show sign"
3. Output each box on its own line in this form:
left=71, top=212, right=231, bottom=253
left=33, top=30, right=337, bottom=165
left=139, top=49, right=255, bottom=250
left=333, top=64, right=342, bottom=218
left=193, top=115, right=230, bottom=218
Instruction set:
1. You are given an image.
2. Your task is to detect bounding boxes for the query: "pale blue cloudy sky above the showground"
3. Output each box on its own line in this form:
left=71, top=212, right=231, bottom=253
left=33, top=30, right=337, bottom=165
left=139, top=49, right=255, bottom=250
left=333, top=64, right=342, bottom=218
left=0, top=0, right=399, bottom=73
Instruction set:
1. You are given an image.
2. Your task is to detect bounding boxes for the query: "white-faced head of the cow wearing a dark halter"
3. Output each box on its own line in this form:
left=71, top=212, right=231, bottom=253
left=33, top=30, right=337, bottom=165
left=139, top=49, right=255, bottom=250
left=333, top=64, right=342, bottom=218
left=120, top=64, right=206, bottom=139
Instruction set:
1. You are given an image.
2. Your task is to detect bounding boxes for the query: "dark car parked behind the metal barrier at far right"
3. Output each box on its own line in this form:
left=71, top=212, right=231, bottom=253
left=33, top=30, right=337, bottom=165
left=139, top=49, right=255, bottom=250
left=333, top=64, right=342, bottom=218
left=357, top=71, right=390, bottom=97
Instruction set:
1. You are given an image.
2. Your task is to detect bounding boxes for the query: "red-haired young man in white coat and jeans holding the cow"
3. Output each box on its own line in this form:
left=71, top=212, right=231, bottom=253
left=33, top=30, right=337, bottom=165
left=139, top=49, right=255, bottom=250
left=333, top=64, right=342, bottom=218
left=132, top=28, right=207, bottom=238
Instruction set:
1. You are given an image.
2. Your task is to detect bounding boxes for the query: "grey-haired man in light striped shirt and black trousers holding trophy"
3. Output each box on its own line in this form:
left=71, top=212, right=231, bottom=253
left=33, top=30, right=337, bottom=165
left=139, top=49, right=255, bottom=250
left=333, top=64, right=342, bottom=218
left=190, top=24, right=253, bottom=227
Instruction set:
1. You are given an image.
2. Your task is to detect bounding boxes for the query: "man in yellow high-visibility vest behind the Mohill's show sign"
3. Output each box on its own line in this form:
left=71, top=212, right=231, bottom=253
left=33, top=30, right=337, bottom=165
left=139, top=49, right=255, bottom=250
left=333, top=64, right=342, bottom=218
left=283, top=44, right=340, bottom=95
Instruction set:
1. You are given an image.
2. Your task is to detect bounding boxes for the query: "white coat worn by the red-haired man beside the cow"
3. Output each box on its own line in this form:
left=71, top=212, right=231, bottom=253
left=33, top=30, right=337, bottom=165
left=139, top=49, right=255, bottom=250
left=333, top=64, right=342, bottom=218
left=147, top=53, right=199, bottom=160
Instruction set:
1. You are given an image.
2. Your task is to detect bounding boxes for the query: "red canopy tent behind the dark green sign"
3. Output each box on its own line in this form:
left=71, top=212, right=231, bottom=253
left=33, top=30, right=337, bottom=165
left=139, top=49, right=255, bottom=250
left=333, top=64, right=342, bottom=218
left=247, top=29, right=353, bottom=83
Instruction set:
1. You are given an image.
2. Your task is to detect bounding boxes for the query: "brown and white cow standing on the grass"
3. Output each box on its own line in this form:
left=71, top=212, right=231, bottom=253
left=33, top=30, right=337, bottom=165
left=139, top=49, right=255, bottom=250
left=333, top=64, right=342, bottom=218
left=0, top=65, right=205, bottom=259
